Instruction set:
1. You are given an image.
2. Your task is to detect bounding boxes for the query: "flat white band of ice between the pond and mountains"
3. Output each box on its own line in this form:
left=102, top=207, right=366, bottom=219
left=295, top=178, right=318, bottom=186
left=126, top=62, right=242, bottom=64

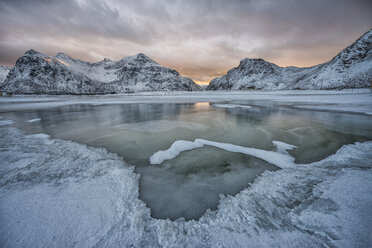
left=0, top=89, right=372, bottom=117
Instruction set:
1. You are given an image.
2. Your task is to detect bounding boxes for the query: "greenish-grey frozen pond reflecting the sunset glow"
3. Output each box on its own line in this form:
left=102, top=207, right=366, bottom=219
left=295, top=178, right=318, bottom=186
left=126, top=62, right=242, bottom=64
left=1, top=100, right=372, bottom=220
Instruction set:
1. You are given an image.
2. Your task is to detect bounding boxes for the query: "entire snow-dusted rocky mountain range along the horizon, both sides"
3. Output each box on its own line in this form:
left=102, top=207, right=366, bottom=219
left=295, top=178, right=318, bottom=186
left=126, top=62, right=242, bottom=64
left=0, top=29, right=372, bottom=94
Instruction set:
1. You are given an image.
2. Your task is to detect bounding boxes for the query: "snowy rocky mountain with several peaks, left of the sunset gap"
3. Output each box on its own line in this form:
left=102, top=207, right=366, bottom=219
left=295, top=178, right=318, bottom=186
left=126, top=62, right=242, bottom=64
left=0, top=49, right=200, bottom=94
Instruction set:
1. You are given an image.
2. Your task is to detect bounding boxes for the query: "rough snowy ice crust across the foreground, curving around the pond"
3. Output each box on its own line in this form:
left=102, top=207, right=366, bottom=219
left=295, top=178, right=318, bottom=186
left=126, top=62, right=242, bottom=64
left=0, top=128, right=372, bottom=247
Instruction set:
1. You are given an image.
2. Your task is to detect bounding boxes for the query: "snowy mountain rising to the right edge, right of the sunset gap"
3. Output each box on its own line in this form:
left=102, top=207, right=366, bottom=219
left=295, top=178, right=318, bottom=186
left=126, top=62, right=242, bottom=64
left=207, top=30, right=372, bottom=90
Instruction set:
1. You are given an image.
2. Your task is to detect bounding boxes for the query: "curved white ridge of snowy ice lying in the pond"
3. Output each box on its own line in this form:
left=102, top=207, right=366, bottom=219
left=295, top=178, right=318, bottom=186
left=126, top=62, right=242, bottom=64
left=150, top=139, right=295, bottom=168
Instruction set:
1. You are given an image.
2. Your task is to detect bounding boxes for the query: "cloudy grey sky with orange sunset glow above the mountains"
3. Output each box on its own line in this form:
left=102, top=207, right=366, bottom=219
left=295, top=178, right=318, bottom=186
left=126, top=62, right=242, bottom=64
left=0, top=0, right=372, bottom=83
